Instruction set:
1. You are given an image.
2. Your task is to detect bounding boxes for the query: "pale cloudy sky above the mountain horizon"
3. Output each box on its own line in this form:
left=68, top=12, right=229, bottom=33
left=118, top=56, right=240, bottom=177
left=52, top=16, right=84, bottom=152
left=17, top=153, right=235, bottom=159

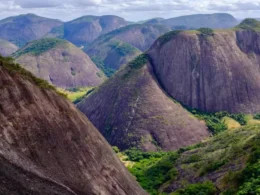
left=0, top=0, right=260, bottom=21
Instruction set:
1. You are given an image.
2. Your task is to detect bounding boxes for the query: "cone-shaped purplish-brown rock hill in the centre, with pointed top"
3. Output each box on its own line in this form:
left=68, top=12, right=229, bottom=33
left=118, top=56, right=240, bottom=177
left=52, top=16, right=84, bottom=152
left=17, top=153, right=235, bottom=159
left=77, top=56, right=209, bottom=151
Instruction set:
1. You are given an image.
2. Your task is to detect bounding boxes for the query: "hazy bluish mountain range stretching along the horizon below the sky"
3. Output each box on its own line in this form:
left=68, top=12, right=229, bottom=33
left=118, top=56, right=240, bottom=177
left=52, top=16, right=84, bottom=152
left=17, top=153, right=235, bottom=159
left=0, top=13, right=242, bottom=76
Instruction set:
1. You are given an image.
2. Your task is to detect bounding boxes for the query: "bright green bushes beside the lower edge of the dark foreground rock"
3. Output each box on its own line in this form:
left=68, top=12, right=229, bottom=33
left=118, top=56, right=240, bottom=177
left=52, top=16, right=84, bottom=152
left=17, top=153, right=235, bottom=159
left=124, top=149, right=179, bottom=195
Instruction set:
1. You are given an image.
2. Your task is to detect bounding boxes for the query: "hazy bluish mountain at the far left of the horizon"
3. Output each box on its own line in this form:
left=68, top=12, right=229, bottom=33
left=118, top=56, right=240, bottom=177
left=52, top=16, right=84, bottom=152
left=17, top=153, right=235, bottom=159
left=0, top=14, right=63, bottom=46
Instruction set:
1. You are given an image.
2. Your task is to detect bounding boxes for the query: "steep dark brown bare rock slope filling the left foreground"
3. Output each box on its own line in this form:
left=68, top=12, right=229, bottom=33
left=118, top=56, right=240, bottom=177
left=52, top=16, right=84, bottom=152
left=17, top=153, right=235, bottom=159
left=0, top=61, right=146, bottom=195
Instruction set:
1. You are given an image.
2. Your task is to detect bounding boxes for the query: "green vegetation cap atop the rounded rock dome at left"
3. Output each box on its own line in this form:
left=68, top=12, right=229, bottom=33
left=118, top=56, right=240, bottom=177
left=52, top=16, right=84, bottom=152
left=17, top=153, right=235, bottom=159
left=14, top=38, right=67, bottom=57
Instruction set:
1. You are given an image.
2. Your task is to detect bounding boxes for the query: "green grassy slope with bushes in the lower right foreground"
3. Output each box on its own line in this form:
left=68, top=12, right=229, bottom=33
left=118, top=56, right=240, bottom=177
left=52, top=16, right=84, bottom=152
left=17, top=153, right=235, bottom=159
left=121, top=125, right=260, bottom=195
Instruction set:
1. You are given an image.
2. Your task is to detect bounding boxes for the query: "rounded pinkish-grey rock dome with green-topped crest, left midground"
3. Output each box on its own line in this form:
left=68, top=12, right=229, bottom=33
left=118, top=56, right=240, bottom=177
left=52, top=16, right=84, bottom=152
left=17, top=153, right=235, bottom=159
left=14, top=38, right=105, bottom=88
